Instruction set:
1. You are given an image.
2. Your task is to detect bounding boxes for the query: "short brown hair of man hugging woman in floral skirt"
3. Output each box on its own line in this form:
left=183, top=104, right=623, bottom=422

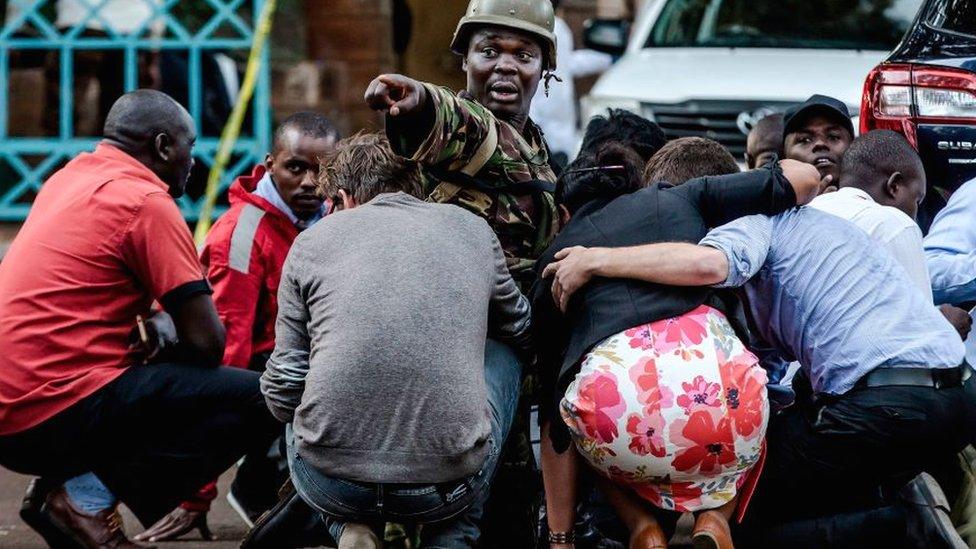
left=644, top=137, right=739, bottom=186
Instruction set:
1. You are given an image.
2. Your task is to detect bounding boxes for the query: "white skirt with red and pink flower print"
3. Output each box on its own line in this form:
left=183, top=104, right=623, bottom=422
left=560, top=305, right=769, bottom=512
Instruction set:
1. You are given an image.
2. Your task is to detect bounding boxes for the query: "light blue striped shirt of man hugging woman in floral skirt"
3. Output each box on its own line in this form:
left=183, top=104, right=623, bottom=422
left=701, top=208, right=965, bottom=394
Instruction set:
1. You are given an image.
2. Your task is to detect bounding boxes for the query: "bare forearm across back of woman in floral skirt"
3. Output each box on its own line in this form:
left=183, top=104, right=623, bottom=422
left=591, top=242, right=729, bottom=286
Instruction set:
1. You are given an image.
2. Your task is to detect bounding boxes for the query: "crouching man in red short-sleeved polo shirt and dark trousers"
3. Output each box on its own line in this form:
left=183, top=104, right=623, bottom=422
left=0, top=90, right=279, bottom=547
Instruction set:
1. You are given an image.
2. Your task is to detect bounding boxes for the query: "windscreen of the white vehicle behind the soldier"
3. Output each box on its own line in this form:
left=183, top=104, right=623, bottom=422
left=645, top=0, right=924, bottom=51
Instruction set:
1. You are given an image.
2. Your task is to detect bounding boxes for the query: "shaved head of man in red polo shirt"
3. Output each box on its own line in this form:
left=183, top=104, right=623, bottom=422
left=104, top=90, right=196, bottom=196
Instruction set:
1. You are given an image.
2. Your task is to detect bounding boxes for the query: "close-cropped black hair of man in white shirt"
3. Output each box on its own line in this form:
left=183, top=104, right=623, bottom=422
left=841, top=130, right=924, bottom=182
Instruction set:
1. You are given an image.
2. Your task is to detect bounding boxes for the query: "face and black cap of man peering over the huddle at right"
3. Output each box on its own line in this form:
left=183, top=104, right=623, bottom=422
left=783, top=95, right=854, bottom=193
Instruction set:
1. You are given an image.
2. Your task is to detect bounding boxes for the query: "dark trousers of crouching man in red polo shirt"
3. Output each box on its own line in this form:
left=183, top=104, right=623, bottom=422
left=0, top=364, right=281, bottom=525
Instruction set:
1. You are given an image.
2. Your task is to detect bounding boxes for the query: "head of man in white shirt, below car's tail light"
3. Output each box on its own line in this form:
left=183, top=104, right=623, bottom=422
left=840, top=130, right=925, bottom=218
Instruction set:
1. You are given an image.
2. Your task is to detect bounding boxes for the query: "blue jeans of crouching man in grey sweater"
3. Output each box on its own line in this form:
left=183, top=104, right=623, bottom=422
left=287, top=339, right=522, bottom=549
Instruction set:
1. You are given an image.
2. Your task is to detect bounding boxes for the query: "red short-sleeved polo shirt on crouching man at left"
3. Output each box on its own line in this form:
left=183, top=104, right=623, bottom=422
left=0, top=143, right=210, bottom=435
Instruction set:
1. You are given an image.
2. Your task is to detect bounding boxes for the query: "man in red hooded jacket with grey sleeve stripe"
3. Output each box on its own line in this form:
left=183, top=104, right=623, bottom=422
left=136, top=112, right=339, bottom=542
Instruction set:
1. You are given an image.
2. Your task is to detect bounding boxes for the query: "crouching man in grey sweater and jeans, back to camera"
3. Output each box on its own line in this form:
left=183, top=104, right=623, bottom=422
left=261, top=134, right=529, bottom=548
